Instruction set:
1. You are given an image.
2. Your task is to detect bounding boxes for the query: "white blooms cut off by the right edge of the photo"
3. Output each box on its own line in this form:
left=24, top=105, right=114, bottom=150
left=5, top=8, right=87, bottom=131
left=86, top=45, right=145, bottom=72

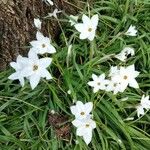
left=137, top=95, right=150, bottom=117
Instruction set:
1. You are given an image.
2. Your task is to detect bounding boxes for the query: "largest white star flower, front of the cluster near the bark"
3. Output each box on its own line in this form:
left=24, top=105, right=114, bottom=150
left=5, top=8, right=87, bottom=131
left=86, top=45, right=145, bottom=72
left=20, top=51, right=52, bottom=89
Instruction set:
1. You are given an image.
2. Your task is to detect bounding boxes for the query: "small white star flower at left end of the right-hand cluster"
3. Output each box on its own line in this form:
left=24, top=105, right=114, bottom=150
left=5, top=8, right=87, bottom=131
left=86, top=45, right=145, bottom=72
left=88, top=73, right=109, bottom=93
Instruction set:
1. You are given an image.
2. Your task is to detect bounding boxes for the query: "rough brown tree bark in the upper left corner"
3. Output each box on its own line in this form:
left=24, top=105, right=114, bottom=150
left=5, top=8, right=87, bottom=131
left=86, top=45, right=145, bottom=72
left=0, top=0, right=78, bottom=70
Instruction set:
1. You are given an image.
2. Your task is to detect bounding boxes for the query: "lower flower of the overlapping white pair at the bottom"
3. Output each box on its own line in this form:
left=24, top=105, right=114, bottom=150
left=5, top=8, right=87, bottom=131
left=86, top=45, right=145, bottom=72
left=72, top=118, right=96, bottom=145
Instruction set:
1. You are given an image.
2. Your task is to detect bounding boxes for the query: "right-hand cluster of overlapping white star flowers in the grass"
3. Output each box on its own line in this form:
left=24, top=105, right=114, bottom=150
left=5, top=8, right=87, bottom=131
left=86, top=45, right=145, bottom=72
left=88, top=65, right=139, bottom=94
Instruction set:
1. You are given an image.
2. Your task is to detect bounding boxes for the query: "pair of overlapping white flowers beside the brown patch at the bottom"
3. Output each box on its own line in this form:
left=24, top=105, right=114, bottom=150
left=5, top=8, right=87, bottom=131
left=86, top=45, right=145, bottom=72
left=70, top=101, right=96, bottom=145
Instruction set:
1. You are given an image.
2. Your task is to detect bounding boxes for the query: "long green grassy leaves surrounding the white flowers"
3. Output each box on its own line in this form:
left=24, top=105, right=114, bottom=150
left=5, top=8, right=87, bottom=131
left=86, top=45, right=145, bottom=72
left=0, top=0, right=150, bottom=150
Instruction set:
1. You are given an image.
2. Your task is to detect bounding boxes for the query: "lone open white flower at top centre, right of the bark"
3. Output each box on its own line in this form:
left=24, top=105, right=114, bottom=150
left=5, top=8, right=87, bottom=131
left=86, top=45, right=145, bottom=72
left=75, top=15, right=98, bottom=41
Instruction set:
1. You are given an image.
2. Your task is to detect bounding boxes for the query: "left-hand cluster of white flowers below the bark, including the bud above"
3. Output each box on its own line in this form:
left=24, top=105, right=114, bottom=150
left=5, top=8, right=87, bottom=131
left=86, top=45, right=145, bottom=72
left=8, top=20, right=56, bottom=89
